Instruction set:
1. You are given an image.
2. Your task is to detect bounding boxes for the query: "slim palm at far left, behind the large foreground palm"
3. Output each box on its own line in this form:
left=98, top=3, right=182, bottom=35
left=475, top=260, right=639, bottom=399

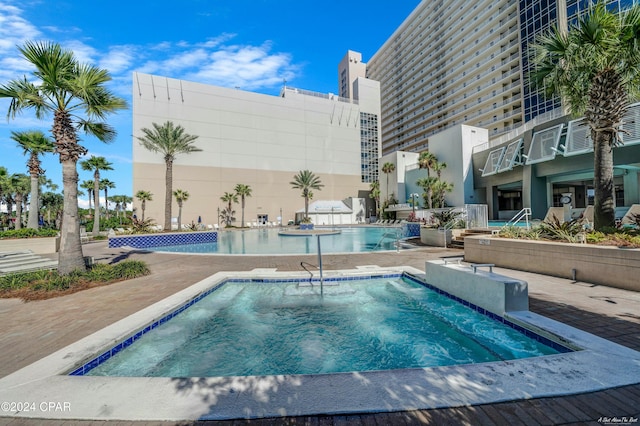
left=11, top=130, right=55, bottom=229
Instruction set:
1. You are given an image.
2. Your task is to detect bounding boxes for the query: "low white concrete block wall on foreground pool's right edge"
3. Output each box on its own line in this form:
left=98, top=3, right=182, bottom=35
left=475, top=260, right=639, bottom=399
left=425, top=260, right=529, bottom=316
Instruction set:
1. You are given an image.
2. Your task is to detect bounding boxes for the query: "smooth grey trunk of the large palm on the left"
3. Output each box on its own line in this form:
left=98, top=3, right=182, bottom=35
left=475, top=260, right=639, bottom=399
left=58, top=159, right=85, bottom=275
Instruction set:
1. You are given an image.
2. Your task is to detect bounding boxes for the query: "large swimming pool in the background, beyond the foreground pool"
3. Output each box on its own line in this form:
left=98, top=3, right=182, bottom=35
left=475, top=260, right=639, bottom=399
left=146, top=226, right=404, bottom=255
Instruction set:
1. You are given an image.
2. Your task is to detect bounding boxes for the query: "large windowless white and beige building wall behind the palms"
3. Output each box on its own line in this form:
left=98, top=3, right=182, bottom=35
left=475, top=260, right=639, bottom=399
left=133, top=73, right=368, bottom=225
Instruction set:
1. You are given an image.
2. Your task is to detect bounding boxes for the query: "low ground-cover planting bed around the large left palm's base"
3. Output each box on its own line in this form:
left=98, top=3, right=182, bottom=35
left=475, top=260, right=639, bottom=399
left=0, top=260, right=150, bottom=301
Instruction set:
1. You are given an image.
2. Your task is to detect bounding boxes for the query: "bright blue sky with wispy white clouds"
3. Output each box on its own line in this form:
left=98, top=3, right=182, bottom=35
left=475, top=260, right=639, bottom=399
left=0, top=0, right=420, bottom=207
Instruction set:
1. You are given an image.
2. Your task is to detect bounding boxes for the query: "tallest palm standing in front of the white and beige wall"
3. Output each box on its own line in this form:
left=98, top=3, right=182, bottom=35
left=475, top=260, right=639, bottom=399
left=137, top=121, right=202, bottom=231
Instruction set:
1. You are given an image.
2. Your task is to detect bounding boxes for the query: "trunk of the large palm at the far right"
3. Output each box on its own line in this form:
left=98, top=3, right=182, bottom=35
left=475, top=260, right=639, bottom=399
left=591, top=131, right=615, bottom=230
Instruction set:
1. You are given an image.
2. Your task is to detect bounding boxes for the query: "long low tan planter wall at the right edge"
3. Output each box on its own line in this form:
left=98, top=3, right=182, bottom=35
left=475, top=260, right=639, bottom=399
left=464, top=236, right=640, bottom=291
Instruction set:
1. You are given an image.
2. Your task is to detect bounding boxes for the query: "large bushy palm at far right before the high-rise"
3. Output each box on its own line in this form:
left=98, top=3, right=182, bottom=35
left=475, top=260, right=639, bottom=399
left=531, top=1, right=640, bottom=230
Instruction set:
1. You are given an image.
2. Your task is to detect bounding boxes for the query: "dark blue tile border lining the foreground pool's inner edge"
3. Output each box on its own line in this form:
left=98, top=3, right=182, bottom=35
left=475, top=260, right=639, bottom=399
left=68, top=272, right=574, bottom=376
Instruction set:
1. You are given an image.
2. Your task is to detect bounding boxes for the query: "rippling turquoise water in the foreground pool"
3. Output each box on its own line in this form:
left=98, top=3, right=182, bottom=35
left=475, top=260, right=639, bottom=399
left=86, top=276, right=558, bottom=377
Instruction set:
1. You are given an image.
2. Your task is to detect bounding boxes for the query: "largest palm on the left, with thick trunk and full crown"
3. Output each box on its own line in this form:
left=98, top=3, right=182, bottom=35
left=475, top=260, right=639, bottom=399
left=0, top=42, right=127, bottom=275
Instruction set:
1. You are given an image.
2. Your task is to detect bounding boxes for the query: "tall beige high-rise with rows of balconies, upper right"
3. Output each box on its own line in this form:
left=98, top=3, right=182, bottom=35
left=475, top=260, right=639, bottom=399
left=362, top=0, right=638, bottom=155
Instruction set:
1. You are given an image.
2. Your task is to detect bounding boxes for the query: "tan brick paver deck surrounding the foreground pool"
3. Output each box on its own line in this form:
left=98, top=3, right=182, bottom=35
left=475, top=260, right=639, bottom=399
left=0, top=243, right=640, bottom=424
